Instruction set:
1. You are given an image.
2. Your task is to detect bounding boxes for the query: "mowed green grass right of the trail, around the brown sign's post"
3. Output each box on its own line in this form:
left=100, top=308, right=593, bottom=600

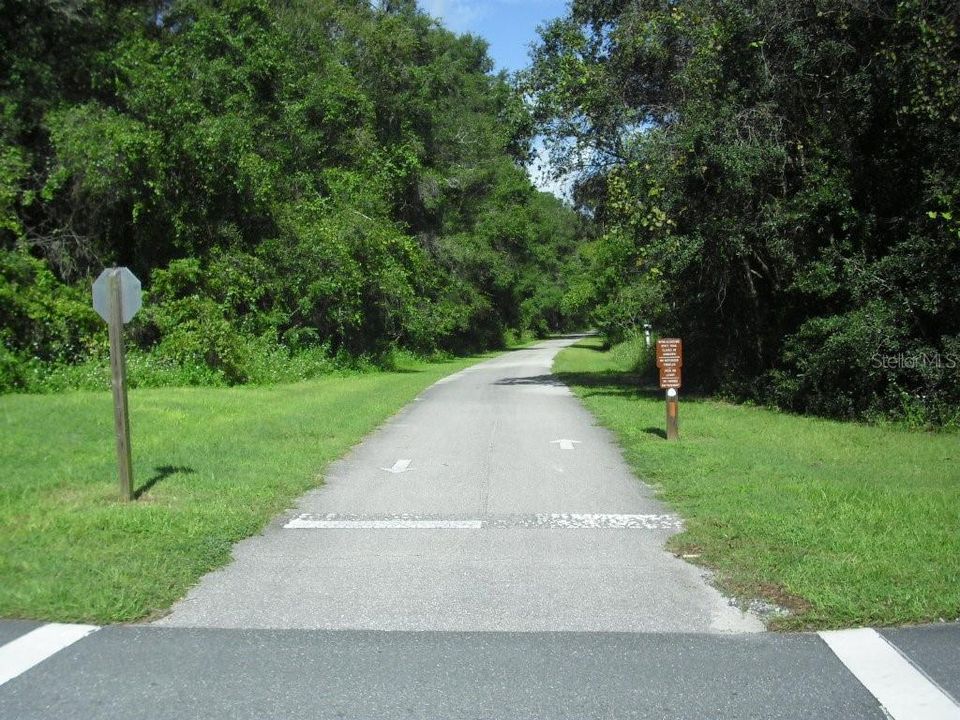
left=554, top=338, right=960, bottom=629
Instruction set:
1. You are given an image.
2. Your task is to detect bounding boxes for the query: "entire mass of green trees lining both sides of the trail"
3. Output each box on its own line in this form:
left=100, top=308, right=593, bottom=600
left=0, top=0, right=960, bottom=424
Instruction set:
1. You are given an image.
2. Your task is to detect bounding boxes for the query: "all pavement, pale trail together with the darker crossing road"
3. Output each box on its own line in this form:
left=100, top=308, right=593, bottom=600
left=0, top=340, right=960, bottom=720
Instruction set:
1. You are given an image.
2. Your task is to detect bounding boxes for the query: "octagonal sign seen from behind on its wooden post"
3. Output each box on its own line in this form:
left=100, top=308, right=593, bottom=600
left=93, top=267, right=142, bottom=500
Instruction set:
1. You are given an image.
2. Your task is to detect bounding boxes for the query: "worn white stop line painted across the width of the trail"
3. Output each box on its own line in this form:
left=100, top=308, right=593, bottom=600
left=284, top=513, right=683, bottom=530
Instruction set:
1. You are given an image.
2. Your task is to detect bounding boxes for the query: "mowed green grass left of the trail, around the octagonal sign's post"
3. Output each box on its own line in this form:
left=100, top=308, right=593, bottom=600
left=0, top=358, right=492, bottom=623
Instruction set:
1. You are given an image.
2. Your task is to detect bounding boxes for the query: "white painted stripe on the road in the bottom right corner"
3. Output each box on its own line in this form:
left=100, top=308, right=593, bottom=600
left=819, top=628, right=960, bottom=720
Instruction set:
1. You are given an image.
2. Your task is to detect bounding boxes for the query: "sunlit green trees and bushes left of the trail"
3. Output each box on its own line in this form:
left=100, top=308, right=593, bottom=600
left=0, top=0, right=581, bottom=390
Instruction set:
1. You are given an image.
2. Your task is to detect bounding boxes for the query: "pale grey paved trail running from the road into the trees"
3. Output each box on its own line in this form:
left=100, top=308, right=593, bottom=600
left=158, top=340, right=763, bottom=632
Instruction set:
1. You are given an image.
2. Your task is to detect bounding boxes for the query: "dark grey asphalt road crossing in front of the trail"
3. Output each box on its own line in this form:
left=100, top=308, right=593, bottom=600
left=0, top=622, right=960, bottom=720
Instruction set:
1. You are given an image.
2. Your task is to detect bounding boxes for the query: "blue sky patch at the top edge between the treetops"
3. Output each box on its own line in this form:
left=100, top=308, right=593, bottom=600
left=419, top=0, right=567, bottom=72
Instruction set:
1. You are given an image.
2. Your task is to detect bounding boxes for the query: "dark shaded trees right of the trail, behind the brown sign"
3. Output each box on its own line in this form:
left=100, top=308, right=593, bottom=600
left=525, top=0, right=960, bottom=425
